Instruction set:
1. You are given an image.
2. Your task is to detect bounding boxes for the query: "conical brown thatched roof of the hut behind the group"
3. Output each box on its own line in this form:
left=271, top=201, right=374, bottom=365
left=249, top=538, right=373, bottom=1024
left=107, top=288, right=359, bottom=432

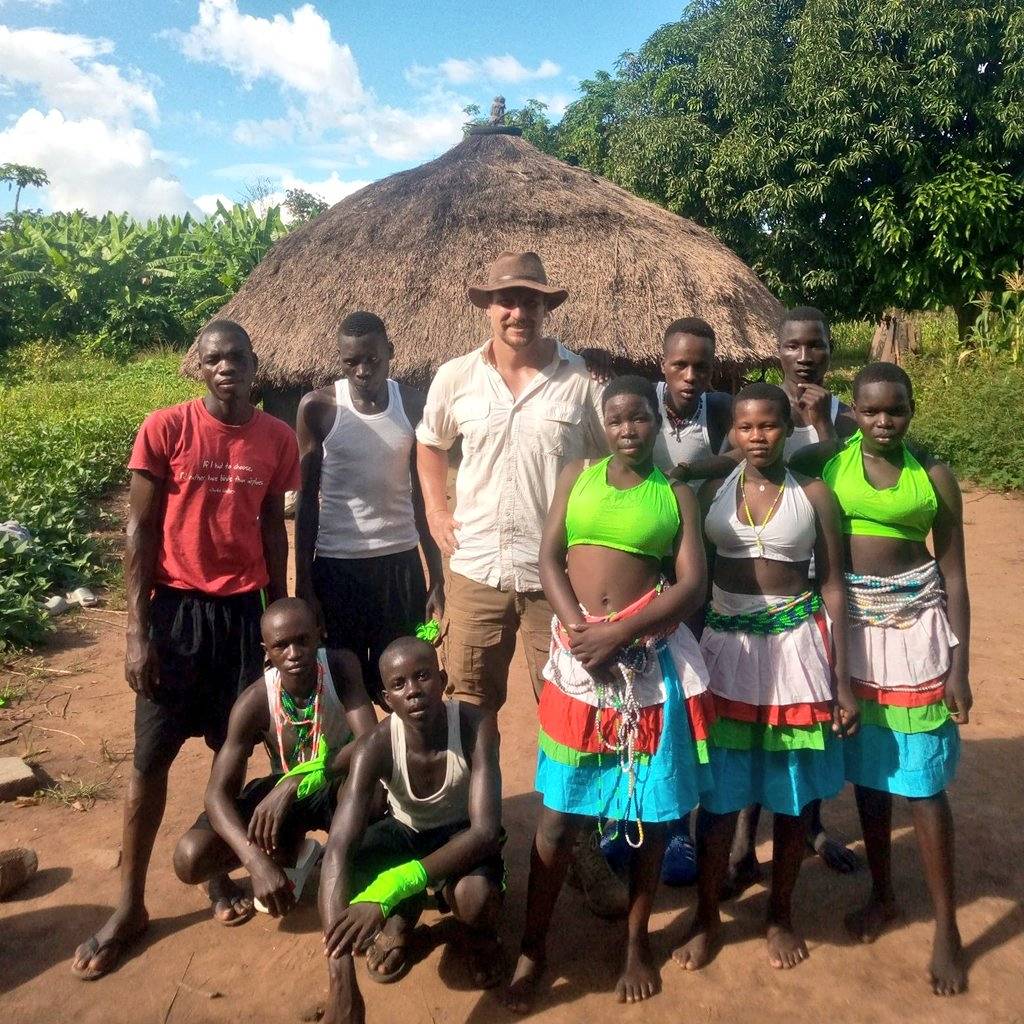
left=184, top=134, right=780, bottom=387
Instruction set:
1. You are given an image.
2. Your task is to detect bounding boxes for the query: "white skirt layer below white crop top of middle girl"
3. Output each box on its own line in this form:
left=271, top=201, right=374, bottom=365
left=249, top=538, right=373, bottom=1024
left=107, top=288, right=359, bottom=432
left=700, top=586, right=831, bottom=708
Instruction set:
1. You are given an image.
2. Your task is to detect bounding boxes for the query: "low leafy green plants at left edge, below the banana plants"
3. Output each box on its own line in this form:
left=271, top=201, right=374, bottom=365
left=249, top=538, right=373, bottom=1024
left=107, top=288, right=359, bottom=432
left=0, top=352, right=198, bottom=651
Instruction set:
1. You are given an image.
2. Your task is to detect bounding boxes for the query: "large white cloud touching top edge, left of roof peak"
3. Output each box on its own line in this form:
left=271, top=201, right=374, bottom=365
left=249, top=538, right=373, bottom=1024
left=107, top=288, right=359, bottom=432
left=173, top=0, right=364, bottom=106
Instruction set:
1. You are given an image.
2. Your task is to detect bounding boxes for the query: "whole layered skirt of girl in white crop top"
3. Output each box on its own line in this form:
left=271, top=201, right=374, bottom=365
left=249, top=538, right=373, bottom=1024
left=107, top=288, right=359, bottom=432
left=700, top=586, right=844, bottom=815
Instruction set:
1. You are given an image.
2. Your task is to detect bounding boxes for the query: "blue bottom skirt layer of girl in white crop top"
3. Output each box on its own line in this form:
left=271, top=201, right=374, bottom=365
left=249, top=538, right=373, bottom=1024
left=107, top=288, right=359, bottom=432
left=702, top=736, right=848, bottom=816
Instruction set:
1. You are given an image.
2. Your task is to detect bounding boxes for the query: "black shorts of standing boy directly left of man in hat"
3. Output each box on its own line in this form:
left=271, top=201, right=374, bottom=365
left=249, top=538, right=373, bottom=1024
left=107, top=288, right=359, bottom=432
left=312, top=548, right=427, bottom=708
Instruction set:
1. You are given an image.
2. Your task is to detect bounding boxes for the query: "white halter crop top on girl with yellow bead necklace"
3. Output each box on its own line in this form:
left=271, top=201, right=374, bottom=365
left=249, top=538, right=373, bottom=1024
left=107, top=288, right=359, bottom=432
left=705, top=462, right=817, bottom=562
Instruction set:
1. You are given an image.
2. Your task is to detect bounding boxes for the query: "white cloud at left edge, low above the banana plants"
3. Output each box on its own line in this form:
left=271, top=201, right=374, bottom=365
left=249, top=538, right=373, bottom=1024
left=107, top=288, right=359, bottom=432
left=0, top=109, right=198, bottom=220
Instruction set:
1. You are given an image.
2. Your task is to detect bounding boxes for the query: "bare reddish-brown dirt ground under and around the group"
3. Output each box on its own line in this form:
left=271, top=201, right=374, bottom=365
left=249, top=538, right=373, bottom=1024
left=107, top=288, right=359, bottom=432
left=0, top=493, right=1024, bottom=1024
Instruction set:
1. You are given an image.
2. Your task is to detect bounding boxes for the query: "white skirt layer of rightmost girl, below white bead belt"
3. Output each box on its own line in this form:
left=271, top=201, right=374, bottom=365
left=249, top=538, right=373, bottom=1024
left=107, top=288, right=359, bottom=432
left=848, top=607, right=959, bottom=690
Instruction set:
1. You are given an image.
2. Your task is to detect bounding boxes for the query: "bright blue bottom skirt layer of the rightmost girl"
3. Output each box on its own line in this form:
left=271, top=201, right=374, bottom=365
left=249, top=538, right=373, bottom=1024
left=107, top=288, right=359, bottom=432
left=843, top=721, right=959, bottom=798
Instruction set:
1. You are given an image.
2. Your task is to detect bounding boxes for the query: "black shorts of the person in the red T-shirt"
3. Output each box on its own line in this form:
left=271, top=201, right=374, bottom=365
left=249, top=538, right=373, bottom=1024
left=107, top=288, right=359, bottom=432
left=135, top=587, right=263, bottom=775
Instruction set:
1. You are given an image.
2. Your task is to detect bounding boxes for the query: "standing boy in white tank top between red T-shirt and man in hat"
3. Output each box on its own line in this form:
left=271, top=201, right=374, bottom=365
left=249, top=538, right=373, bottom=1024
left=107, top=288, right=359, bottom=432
left=295, top=312, right=443, bottom=703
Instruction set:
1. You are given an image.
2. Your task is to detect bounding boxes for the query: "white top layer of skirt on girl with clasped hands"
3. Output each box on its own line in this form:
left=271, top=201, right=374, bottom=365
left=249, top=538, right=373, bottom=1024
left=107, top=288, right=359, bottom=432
left=544, top=617, right=708, bottom=708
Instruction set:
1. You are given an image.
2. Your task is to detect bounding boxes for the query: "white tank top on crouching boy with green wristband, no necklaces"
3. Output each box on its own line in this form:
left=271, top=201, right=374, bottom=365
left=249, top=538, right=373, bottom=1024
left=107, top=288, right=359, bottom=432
left=386, top=700, right=469, bottom=831
